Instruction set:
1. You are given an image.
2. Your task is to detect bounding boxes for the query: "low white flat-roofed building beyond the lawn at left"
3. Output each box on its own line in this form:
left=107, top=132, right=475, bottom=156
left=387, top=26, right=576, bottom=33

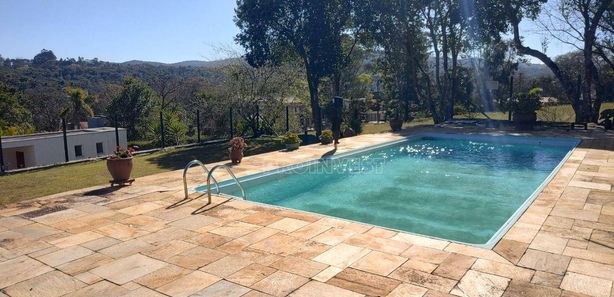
left=2, top=127, right=128, bottom=170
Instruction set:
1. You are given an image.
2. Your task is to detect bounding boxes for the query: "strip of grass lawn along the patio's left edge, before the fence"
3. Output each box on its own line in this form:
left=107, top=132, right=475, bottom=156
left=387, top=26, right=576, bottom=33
left=0, top=137, right=283, bottom=205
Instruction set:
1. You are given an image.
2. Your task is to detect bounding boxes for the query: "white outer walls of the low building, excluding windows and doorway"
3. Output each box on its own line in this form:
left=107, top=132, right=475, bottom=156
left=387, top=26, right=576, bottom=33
left=2, top=129, right=128, bottom=170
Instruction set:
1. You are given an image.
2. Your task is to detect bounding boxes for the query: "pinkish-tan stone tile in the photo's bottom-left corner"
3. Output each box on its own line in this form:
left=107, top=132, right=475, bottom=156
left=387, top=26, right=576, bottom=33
left=4, top=271, right=86, bottom=297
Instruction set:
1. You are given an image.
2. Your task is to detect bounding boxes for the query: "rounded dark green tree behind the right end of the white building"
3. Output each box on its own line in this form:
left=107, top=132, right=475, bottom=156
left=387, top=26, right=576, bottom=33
left=107, top=78, right=157, bottom=140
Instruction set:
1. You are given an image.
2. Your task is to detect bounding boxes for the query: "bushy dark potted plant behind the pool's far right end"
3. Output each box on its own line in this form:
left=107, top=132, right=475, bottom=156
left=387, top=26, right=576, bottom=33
left=510, top=88, right=541, bottom=130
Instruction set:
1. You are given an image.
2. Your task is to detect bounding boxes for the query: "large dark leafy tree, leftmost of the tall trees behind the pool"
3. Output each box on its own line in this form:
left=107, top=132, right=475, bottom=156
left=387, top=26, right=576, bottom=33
left=235, top=0, right=352, bottom=135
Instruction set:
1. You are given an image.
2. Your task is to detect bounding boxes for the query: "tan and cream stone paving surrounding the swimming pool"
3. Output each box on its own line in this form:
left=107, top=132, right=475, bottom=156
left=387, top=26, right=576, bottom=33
left=0, top=127, right=614, bottom=297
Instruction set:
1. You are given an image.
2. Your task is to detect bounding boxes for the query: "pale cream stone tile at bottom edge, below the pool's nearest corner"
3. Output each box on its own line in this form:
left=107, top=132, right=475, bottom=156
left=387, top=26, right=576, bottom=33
left=458, top=270, right=510, bottom=296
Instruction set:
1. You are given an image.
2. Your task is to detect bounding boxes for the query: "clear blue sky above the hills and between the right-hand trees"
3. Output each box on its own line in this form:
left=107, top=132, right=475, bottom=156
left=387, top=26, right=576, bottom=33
left=0, top=0, right=570, bottom=63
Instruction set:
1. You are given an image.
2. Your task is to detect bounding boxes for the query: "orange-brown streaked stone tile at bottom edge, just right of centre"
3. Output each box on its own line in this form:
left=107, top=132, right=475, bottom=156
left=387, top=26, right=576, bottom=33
left=326, top=268, right=401, bottom=296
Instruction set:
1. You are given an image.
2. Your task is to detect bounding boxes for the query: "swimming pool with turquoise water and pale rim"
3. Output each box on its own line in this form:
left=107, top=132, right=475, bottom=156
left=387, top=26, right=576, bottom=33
left=196, top=133, right=579, bottom=248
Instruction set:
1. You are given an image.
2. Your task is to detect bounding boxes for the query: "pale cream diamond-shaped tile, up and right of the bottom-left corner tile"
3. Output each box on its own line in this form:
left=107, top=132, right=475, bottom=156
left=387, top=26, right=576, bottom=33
left=91, top=254, right=167, bottom=284
